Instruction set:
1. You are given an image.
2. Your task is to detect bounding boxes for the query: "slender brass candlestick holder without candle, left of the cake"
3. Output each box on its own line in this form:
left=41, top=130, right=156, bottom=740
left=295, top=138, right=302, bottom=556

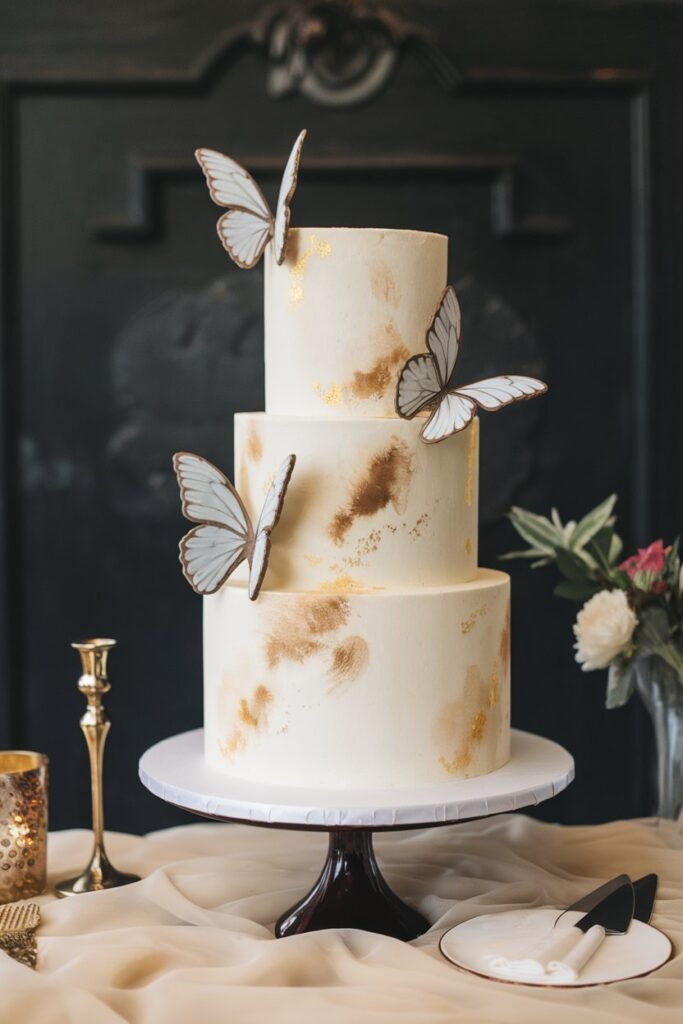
left=54, top=639, right=140, bottom=896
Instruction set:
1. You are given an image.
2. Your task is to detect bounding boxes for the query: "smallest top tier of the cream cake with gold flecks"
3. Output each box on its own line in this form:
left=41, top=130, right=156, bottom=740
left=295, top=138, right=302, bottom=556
left=264, top=227, right=449, bottom=417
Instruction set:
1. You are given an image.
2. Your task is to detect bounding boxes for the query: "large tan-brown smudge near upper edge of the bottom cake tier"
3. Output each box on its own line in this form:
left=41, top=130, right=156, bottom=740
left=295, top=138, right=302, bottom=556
left=265, top=595, right=350, bottom=669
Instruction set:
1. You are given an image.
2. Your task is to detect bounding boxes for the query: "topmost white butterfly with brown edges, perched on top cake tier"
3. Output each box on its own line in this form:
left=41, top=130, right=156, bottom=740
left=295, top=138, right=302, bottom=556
left=195, top=129, right=306, bottom=269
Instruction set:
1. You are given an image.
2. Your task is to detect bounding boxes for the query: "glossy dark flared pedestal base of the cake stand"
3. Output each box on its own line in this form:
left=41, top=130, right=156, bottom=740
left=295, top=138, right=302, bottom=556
left=275, top=828, right=429, bottom=941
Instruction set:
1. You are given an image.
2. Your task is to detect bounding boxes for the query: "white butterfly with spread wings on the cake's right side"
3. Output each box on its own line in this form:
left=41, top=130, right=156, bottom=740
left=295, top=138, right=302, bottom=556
left=396, top=285, right=548, bottom=444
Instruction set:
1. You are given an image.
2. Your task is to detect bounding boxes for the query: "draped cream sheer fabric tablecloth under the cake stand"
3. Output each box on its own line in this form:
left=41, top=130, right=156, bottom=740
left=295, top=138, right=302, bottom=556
left=0, top=815, right=683, bottom=1024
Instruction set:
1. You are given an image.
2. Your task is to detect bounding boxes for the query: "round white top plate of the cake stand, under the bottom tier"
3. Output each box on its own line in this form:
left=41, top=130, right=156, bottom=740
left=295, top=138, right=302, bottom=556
left=139, top=729, right=573, bottom=829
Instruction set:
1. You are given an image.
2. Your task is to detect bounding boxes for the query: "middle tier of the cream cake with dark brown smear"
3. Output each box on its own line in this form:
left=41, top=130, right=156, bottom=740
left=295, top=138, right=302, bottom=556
left=234, top=413, right=479, bottom=592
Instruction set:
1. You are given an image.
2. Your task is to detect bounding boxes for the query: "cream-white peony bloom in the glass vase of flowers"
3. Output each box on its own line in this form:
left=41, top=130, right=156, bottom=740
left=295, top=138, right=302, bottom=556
left=573, top=590, right=638, bottom=672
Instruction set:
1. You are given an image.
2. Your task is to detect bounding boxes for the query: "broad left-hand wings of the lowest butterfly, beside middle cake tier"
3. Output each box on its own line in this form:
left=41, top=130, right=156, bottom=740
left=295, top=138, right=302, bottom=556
left=173, top=452, right=253, bottom=594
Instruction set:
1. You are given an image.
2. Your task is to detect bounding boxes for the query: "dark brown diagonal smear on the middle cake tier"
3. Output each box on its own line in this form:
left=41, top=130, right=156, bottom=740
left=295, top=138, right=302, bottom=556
left=328, top=436, right=414, bottom=544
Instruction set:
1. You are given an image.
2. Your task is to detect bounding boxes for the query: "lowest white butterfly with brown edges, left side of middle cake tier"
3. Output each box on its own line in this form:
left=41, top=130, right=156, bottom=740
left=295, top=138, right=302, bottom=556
left=173, top=452, right=296, bottom=601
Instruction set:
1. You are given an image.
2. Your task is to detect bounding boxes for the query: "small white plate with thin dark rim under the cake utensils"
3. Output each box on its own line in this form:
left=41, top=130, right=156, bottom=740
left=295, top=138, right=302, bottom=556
left=439, top=907, right=672, bottom=988
